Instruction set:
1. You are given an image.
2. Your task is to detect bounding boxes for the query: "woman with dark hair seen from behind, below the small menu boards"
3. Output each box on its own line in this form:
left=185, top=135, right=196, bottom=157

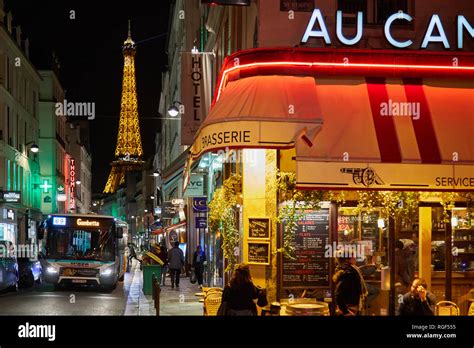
left=222, top=264, right=259, bottom=316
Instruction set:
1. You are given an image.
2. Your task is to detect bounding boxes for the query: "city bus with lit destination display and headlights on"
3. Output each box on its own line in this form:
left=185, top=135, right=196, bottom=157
left=39, top=214, right=128, bottom=291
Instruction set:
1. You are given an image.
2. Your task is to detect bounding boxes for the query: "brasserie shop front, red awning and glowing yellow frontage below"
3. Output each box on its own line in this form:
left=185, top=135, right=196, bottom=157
left=184, top=48, right=474, bottom=315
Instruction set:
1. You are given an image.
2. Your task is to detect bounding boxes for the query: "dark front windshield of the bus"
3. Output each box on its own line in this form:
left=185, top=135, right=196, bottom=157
left=47, top=227, right=115, bottom=261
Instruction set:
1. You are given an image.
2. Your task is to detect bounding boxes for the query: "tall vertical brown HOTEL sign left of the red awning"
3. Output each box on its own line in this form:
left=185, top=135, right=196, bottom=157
left=180, top=52, right=213, bottom=145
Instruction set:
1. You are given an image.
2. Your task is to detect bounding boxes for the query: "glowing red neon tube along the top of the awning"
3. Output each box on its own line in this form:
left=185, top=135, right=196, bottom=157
left=216, top=61, right=474, bottom=101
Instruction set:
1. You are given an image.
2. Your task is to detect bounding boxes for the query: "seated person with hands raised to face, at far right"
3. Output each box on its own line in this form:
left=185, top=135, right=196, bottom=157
left=398, top=278, right=436, bottom=316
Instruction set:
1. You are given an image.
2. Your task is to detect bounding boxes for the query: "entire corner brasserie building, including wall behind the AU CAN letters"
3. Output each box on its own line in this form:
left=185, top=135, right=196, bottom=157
left=162, top=0, right=474, bottom=315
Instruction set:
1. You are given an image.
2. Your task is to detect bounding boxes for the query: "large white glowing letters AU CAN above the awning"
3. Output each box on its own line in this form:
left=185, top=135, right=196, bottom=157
left=301, top=9, right=474, bottom=49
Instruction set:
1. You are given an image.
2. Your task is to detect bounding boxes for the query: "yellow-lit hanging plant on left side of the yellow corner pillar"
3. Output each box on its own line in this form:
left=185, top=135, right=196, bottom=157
left=209, top=174, right=241, bottom=271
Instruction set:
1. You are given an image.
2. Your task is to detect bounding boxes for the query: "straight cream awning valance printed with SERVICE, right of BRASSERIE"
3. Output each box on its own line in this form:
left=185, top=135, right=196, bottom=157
left=296, top=161, right=474, bottom=191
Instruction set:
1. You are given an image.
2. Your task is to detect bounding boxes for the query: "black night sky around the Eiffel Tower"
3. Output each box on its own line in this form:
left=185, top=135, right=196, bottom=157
left=5, top=0, right=170, bottom=193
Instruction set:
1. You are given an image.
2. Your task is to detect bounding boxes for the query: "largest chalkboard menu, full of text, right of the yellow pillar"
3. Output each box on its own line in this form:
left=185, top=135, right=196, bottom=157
left=281, top=209, right=330, bottom=288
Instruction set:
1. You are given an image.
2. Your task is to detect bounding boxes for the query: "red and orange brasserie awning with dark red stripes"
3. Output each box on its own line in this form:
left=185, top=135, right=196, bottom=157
left=184, top=49, right=474, bottom=190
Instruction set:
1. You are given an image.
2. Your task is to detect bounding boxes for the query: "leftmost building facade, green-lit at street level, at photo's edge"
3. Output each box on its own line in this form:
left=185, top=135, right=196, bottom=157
left=0, top=1, right=41, bottom=244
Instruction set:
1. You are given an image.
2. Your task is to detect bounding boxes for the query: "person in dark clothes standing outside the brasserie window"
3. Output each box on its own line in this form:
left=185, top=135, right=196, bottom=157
left=333, top=253, right=368, bottom=316
